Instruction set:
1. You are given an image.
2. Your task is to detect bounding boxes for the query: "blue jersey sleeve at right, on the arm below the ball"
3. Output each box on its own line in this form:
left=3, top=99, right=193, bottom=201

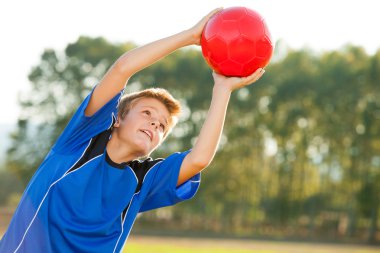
left=140, top=151, right=201, bottom=212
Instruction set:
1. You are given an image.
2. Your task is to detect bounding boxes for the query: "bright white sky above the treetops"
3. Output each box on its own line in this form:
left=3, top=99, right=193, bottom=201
left=0, top=0, right=380, bottom=124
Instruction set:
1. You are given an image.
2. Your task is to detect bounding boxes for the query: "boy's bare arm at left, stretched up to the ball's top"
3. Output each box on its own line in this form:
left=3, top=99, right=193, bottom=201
left=85, top=8, right=221, bottom=116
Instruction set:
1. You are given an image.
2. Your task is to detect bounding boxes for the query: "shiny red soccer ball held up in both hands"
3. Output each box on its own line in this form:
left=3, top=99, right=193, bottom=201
left=201, top=7, right=274, bottom=77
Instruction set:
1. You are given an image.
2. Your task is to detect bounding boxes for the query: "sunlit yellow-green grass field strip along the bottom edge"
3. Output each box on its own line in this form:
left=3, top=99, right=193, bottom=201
left=123, top=236, right=380, bottom=253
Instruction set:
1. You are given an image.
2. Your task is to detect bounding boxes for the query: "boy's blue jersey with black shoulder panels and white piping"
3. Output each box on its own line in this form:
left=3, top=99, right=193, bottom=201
left=0, top=87, right=200, bottom=253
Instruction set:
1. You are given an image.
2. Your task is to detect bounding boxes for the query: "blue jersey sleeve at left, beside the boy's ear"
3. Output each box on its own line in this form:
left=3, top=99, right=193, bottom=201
left=52, top=86, right=124, bottom=154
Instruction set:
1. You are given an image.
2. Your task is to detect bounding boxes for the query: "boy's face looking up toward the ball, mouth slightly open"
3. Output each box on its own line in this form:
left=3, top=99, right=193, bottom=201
left=114, top=98, right=170, bottom=156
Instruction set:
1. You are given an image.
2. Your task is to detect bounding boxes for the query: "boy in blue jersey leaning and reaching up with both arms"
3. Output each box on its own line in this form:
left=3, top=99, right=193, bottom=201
left=0, top=9, right=264, bottom=253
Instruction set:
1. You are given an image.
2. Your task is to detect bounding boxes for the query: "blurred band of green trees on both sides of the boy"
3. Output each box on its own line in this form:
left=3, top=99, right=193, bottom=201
left=5, top=37, right=380, bottom=242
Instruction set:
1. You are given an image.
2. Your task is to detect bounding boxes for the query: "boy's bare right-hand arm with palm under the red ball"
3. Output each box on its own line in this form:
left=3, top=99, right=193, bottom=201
left=177, top=68, right=265, bottom=186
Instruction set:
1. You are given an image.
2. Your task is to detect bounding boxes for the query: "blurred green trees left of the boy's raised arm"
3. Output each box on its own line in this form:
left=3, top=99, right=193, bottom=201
left=7, top=37, right=133, bottom=185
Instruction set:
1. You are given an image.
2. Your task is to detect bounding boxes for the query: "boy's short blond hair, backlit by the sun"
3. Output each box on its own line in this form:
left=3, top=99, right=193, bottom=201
left=118, top=88, right=181, bottom=136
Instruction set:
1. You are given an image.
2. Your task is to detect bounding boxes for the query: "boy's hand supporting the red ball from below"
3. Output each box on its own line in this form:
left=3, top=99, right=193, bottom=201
left=212, top=68, right=265, bottom=92
